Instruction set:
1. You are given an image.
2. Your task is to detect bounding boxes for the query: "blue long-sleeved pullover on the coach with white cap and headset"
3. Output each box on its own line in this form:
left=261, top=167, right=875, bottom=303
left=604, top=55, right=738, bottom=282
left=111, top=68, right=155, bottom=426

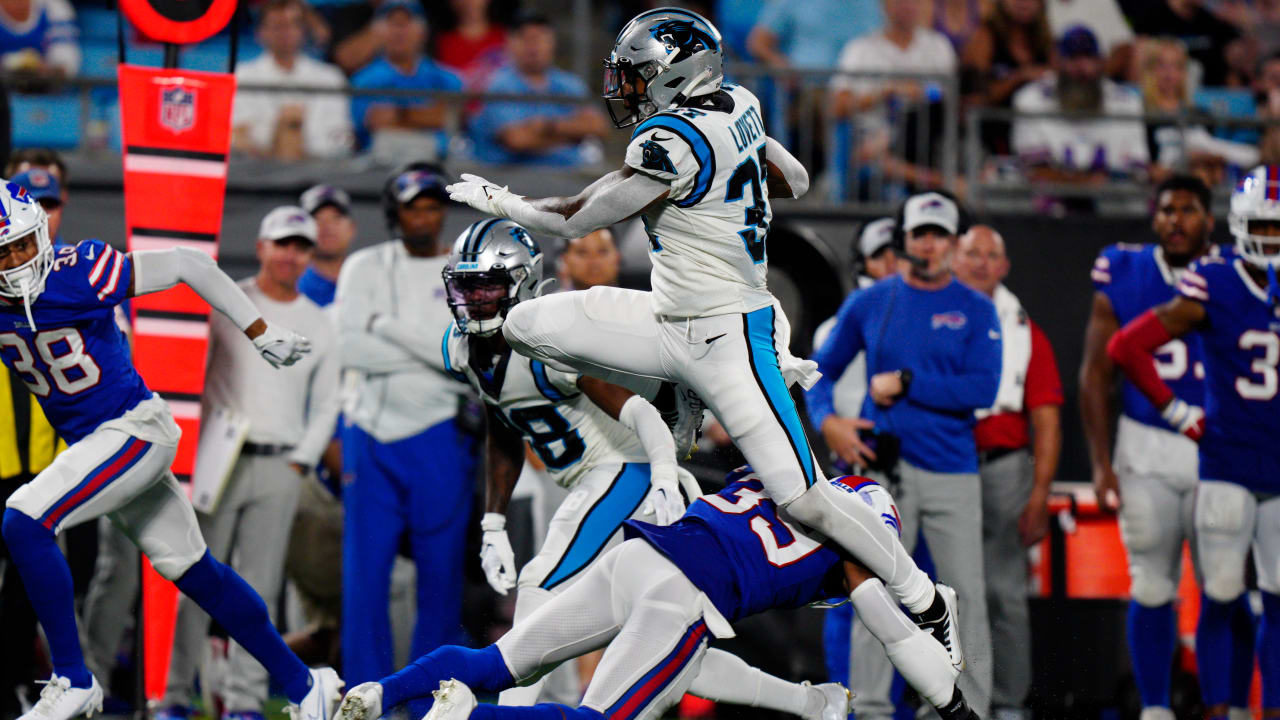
left=805, top=275, right=1001, bottom=473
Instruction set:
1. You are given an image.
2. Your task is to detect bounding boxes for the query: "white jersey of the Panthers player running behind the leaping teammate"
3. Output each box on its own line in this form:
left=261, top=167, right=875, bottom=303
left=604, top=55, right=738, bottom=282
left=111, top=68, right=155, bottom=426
left=443, top=324, right=649, bottom=488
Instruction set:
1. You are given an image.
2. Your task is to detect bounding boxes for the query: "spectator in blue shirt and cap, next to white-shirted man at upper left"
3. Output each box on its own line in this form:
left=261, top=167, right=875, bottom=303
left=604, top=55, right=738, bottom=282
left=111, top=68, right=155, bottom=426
left=351, top=0, right=462, bottom=154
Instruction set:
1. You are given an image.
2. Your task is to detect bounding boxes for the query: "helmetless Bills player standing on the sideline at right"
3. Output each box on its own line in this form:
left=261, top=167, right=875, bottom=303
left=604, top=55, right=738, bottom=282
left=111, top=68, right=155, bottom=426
left=1080, top=176, right=1253, bottom=720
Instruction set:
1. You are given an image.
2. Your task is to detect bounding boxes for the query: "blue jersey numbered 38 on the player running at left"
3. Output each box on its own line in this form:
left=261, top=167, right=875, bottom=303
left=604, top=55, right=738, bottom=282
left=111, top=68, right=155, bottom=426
left=0, top=240, right=151, bottom=443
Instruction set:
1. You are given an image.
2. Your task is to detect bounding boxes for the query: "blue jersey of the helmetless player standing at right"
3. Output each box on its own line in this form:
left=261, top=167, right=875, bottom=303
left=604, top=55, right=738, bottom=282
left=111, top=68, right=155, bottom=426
left=1091, top=243, right=1217, bottom=432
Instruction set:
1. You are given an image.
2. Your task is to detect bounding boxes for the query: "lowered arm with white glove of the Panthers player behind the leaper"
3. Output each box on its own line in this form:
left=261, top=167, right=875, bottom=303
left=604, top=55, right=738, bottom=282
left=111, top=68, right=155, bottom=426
left=480, top=404, right=525, bottom=594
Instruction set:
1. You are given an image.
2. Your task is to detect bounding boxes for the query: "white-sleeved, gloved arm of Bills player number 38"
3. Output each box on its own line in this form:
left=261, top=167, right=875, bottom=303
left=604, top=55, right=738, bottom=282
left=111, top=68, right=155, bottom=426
left=128, top=247, right=311, bottom=368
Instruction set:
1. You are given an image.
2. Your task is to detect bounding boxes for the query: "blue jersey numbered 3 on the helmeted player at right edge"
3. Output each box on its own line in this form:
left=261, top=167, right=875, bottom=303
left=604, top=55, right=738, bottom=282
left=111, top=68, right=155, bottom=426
left=1178, top=258, right=1280, bottom=493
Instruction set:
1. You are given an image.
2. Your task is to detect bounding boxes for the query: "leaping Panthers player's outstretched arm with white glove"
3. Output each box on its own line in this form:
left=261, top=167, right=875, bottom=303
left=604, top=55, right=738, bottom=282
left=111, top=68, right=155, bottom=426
left=445, top=167, right=671, bottom=237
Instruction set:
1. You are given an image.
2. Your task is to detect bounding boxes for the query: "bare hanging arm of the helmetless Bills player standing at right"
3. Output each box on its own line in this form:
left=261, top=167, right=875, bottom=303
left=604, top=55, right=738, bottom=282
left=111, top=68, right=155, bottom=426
left=1076, top=292, right=1120, bottom=510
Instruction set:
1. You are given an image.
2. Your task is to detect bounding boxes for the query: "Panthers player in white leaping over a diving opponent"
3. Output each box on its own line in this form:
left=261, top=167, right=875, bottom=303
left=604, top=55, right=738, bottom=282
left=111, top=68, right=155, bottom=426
left=448, top=8, right=963, bottom=667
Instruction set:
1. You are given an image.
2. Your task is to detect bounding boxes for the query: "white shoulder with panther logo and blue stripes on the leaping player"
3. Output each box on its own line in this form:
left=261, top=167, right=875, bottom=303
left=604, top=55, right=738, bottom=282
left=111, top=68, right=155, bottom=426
left=626, top=113, right=716, bottom=205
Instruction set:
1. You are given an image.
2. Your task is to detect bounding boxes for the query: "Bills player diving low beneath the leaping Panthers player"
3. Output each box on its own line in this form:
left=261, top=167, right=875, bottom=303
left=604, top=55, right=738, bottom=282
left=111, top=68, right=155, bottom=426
left=337, top=468, right=977, bottom=720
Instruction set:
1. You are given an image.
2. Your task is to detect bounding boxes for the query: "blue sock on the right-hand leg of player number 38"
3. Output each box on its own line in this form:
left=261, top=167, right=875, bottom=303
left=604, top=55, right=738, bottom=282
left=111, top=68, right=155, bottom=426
left=174, top=551, right=311, bottom=702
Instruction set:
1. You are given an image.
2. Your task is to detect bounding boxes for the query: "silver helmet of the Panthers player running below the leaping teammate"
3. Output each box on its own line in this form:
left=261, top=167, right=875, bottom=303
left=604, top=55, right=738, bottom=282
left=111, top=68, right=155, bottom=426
left=444, top=219, right=543, bottom=336
